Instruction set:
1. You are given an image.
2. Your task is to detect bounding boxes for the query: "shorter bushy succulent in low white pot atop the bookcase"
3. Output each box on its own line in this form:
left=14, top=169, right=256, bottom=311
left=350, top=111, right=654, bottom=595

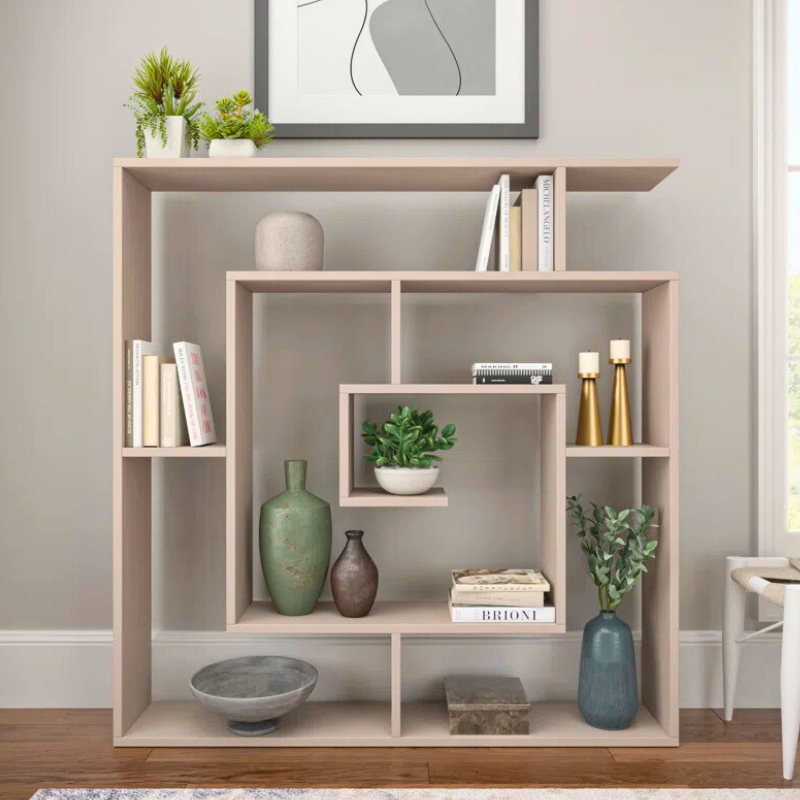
left=200, top=89, right=274, bottom=158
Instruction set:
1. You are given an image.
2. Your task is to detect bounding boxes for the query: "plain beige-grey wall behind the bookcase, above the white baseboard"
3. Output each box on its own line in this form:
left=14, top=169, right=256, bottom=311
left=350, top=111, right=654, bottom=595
left=0, top=0, right=755, bottom=629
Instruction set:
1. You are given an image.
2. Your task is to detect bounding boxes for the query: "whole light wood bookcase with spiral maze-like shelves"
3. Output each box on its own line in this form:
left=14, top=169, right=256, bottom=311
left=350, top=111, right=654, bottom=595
left=113, top=158, right=679, bottom=747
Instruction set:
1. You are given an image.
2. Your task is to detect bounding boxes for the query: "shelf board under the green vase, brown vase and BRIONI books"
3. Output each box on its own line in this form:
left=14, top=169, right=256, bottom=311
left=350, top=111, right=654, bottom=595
left=227, top=600, right=566, bottom=636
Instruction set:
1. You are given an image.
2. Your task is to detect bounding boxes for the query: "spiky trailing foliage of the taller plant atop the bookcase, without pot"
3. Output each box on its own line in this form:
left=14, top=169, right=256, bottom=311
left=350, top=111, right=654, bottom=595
left=125, top=47, right=203, bottom=158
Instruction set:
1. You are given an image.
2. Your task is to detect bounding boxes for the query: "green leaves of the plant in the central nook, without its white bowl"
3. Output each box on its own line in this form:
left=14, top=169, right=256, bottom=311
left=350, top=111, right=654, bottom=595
left=361, top=406, right=458, bottom=467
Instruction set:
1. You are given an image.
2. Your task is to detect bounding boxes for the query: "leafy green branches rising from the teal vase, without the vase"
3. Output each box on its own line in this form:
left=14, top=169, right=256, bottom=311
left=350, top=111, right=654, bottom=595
left=567, top=495, right=658, bottom=611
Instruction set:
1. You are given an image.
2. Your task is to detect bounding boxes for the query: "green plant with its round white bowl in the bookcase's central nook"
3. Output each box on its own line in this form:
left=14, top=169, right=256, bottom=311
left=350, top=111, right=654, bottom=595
left=361, top=406, right=458, bottom=495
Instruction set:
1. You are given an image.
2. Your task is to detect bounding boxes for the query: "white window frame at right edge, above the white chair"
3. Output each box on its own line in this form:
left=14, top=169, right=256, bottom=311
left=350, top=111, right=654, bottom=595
left=753, top=0, right=800, bottom=600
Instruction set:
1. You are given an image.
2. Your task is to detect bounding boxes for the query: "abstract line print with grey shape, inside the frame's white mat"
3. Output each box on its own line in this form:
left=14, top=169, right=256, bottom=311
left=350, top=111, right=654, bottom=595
left=297, top=0, right=497, bottom=97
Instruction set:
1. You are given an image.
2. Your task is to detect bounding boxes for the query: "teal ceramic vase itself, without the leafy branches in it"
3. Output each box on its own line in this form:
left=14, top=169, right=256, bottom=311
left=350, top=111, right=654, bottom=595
left=578, top=611, right=639, bottom=731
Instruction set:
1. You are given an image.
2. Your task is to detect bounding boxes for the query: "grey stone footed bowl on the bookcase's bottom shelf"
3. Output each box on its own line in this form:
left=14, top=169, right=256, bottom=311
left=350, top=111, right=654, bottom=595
left=189, top=656, right=319, bottom=736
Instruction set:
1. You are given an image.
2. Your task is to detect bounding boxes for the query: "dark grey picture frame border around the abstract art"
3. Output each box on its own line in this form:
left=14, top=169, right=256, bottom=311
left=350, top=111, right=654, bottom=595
left=253, top=0, right=539, bottom=139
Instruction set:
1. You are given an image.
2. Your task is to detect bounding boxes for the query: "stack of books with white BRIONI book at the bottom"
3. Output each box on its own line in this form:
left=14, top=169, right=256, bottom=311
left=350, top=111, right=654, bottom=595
left=448, top=569, right=556, bottom=622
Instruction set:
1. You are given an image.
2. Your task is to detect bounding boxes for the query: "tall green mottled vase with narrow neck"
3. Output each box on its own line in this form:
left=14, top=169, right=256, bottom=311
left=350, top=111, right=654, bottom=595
left=259, top=461, right=331, bottom=617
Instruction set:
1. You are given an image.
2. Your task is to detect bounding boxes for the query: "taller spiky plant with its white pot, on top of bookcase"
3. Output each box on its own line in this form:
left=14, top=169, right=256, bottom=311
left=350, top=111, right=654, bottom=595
left=126, top=47, right=202, bottom=158
